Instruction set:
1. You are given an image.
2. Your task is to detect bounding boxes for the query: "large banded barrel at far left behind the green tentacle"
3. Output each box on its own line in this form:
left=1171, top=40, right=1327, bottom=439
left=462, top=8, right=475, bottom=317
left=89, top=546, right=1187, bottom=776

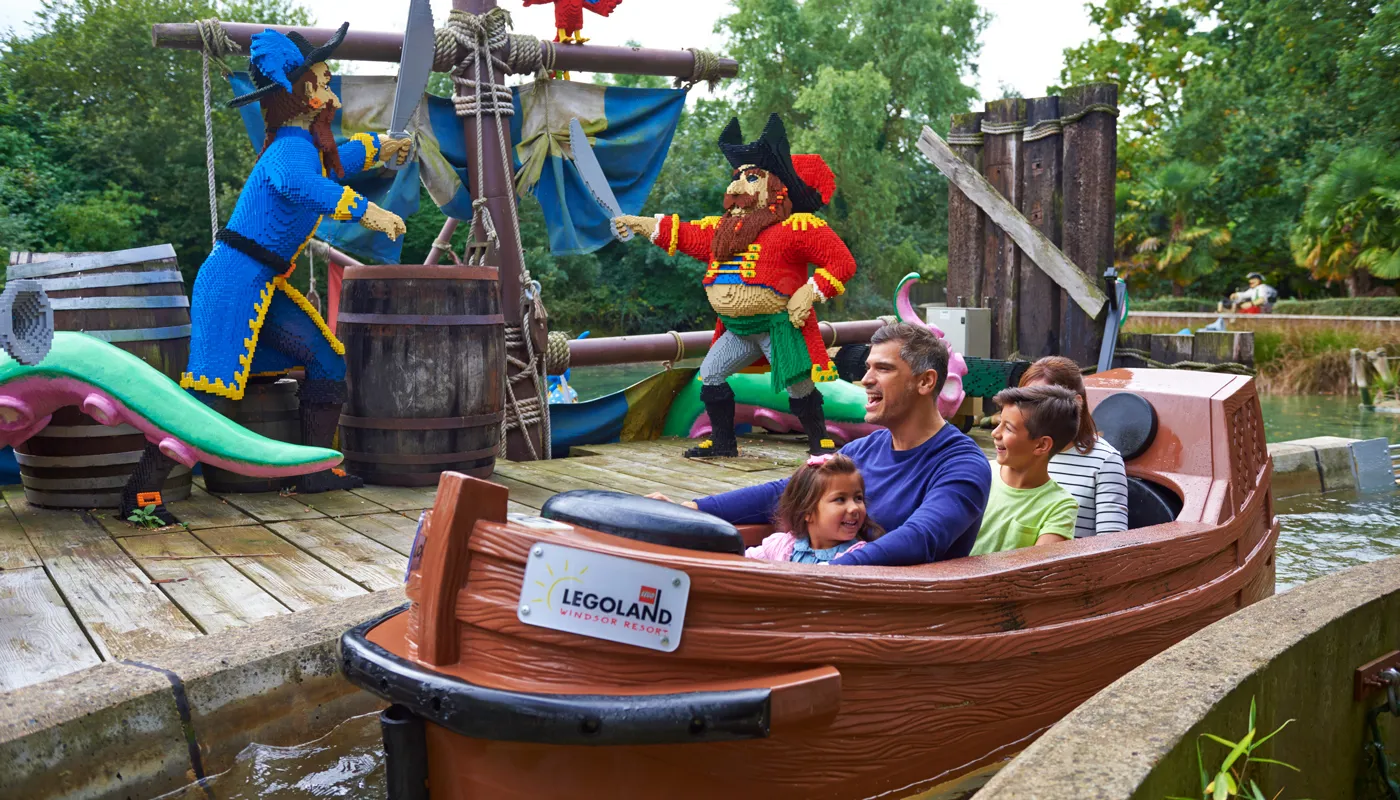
left=6, top=244, right=190, bottom=509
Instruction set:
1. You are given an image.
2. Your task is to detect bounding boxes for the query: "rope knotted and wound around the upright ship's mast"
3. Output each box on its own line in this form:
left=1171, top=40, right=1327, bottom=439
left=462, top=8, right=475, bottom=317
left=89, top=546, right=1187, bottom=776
left=433, top=8, right=554, bottom=460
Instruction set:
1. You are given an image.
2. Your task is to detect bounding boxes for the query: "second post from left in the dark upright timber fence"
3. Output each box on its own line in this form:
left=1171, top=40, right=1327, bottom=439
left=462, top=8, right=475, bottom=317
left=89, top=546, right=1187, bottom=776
left=981, top=98, right=1026, bottom=359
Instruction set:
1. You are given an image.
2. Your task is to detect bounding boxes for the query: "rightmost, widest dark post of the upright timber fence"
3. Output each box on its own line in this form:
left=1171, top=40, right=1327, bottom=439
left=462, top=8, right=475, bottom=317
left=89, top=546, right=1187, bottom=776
left=1060, top=83, right=1119, bottom=364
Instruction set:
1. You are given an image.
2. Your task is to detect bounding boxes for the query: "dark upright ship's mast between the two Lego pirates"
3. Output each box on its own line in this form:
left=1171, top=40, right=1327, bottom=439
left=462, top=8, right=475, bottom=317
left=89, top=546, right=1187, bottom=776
left=452, top=0, right=549, bottom=461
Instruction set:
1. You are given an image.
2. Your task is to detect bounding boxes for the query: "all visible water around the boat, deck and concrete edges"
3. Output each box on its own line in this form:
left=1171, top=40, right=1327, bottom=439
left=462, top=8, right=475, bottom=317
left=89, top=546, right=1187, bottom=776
left=161, top=381, right=1400, bottom=800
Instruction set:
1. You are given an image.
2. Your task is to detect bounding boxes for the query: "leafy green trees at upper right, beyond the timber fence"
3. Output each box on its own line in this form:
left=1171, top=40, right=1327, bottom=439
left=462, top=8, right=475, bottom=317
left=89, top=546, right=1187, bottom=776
left=1061, top=0, right=1400, bottom=296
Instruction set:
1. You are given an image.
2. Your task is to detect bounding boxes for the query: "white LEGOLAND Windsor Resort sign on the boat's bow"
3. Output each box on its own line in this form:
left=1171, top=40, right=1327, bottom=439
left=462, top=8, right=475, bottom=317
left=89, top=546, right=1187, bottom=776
left=515, top=544, right=690, bottom=653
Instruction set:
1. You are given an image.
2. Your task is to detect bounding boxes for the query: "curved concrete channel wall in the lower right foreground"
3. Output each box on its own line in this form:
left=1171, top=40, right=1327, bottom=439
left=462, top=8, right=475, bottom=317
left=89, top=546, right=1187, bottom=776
left=977, top=559, right=1400, bottom=800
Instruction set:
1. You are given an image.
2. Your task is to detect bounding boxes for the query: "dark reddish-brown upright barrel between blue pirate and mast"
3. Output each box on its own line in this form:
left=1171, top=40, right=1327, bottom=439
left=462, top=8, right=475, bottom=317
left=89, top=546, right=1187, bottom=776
left=337, top=266, right=505, bottom=486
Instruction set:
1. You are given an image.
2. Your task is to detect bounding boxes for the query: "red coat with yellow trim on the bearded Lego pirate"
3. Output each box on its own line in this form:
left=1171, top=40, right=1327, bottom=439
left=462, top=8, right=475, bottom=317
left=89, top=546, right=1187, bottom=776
left=651, top=213, right=855, bottom=380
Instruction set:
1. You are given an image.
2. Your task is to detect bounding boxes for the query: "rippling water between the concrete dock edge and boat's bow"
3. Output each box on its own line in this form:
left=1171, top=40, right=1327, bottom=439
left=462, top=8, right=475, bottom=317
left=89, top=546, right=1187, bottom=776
left=158, top=713, right=385, bottom=800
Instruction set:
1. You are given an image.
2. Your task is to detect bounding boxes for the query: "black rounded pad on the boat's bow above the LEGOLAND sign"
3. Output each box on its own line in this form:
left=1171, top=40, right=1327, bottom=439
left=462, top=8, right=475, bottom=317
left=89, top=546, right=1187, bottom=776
left=540, top=489, right=743, bottom=555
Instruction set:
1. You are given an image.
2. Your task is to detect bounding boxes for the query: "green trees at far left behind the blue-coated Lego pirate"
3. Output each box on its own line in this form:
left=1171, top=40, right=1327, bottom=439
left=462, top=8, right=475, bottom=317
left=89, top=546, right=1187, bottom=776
left=0, top=0, right=309, bottom=280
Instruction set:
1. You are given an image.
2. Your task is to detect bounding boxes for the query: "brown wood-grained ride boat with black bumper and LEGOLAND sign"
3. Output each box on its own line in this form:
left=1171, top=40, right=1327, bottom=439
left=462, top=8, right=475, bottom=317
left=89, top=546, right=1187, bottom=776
left=342, top=370, right=1278, bottom=800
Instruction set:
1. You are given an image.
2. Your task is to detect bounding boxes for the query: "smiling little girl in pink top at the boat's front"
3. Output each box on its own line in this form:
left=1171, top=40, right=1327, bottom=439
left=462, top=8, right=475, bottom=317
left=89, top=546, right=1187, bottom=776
left=743, top=453, right=883, bottom=563
